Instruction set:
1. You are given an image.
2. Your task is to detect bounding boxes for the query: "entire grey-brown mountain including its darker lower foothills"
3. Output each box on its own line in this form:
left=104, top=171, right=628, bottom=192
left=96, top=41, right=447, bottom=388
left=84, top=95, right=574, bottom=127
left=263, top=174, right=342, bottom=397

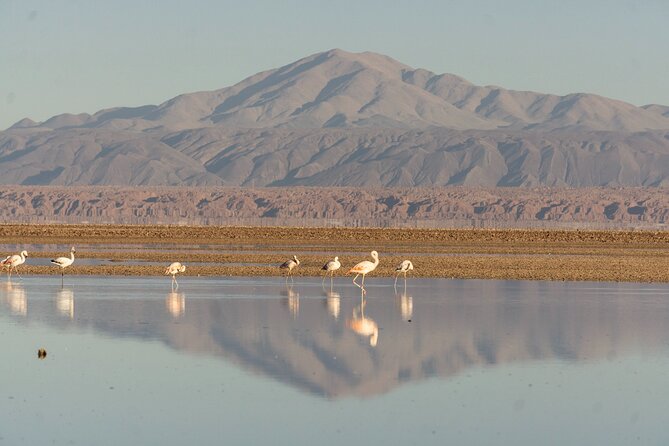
left=0, top=50, right=669, bottom=187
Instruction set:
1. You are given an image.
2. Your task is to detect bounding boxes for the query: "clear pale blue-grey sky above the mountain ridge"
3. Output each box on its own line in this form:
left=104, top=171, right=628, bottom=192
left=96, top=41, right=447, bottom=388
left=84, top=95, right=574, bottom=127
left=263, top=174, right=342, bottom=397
left=0, top=0, right=669, bottom=129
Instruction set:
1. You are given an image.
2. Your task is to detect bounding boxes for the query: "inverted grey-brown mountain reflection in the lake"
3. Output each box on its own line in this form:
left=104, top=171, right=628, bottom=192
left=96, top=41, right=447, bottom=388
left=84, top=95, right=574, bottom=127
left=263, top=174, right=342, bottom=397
left=0, top=281, right=669, bottom=398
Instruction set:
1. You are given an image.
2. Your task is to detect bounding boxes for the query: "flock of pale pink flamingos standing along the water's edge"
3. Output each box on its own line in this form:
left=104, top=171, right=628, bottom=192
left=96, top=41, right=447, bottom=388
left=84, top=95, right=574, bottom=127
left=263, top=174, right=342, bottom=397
left=0, top=246, right=414, bottom=293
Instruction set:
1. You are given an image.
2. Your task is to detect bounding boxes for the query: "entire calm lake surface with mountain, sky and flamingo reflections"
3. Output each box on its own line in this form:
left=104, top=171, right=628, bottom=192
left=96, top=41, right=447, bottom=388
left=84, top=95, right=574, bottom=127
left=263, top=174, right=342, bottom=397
left=0, top=276, right=669, bottom=445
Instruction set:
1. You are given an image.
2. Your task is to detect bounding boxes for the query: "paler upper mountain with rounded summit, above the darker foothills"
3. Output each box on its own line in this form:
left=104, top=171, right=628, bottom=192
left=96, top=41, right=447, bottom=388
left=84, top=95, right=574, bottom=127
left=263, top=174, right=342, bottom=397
left=7, top=48, right=669, bottom=132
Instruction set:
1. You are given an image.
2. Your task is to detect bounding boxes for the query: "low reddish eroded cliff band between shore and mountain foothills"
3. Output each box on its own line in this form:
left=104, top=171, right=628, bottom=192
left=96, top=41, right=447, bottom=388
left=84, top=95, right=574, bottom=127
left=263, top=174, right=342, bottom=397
left=0, top=186, right=669, bottom=227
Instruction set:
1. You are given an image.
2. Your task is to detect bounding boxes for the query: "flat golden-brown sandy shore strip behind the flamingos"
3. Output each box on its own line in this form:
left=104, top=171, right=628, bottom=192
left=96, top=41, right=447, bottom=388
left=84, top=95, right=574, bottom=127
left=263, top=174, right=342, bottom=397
left=0, top=225, right=669, bottom=282
